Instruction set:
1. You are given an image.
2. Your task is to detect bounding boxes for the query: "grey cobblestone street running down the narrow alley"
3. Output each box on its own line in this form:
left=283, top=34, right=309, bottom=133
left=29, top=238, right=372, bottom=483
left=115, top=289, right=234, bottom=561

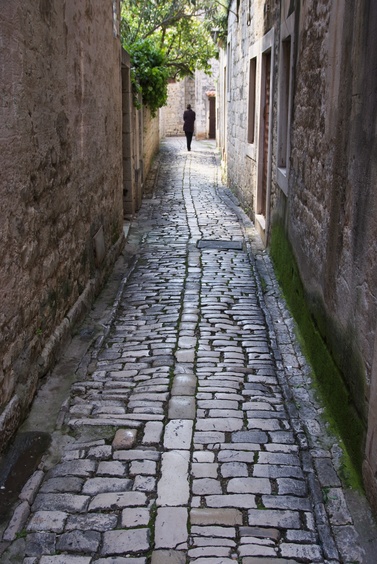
left=0, top=138, right=372, bottom=564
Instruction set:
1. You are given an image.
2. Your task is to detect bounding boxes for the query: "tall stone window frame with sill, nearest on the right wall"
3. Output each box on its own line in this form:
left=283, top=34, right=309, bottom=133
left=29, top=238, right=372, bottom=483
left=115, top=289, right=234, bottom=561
left=276, top=12, right=295, bottom=196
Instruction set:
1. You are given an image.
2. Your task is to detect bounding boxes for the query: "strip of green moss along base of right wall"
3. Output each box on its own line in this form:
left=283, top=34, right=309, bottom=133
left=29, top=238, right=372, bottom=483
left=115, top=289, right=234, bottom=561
left=270, top=224, right=365, bottom=485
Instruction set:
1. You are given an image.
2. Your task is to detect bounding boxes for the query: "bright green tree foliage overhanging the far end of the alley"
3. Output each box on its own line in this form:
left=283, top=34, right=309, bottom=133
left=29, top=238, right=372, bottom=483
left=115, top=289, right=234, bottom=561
left=121, top=0, right=227, bottom=114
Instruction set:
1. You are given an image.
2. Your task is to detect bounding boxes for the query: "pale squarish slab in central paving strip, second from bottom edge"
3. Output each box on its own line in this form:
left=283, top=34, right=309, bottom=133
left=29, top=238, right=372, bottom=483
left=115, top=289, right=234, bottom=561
left=155, top=507, right=188, bottom=549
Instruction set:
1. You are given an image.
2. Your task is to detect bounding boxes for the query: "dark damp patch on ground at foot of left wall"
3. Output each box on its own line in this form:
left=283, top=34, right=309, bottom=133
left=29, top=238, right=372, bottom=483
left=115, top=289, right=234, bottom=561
left=0, top=431, right=51, bottom=523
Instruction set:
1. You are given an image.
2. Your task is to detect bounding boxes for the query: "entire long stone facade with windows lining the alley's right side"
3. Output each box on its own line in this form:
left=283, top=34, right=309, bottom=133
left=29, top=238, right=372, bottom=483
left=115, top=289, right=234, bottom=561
left=218, top=0, right=377, bottom=509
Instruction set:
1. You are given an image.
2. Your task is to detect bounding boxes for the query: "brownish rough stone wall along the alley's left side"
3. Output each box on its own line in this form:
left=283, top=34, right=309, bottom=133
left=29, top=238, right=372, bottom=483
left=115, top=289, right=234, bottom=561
left=0, top=0, right=123, bottom=448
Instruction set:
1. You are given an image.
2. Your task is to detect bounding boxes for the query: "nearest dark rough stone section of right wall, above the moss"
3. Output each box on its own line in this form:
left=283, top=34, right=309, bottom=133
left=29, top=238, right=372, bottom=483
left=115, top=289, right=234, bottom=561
left=289, top=0, right=377, bottom=421
